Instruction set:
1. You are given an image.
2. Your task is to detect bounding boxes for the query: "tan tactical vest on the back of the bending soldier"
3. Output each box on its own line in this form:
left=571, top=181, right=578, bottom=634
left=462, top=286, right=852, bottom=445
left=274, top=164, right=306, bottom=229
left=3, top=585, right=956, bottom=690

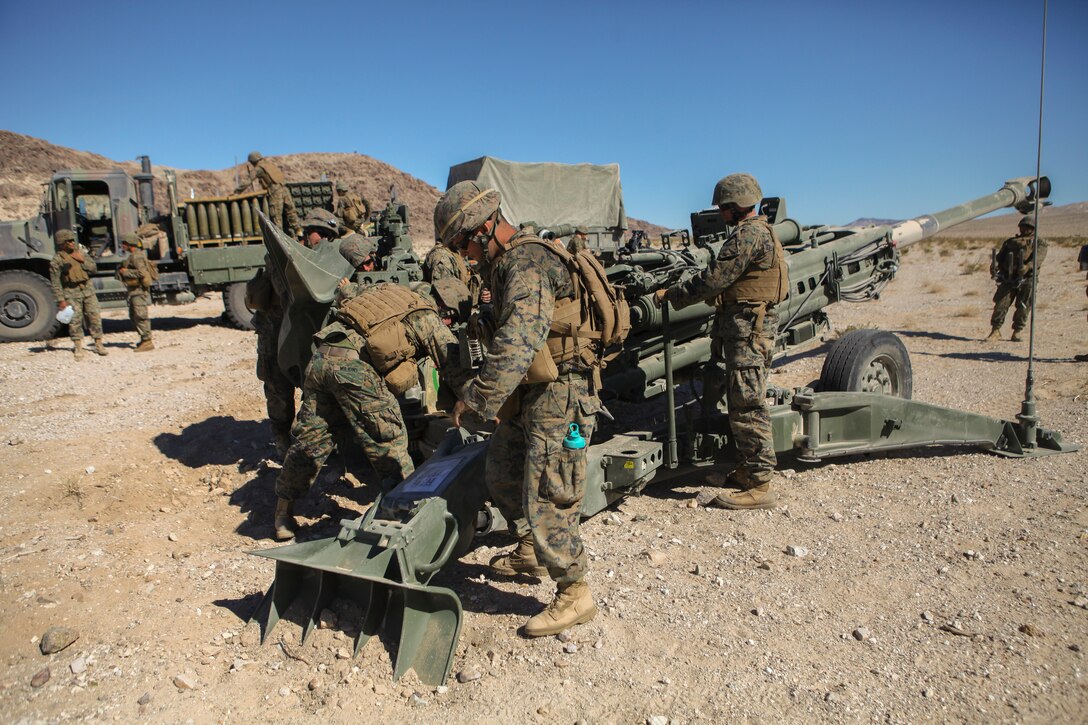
left=336, top=282, right=437, bottom=395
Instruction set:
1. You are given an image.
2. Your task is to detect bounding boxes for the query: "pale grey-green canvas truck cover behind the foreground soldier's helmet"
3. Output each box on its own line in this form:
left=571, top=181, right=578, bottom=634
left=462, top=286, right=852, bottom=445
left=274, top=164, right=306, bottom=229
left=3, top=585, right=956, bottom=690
left=446, top=156, right=627, bottom=230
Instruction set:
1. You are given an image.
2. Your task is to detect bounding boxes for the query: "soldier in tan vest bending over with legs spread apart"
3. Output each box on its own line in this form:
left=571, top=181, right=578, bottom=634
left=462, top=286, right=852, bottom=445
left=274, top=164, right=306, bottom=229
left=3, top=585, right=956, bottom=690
left=274, top=282, right=463, bottom=541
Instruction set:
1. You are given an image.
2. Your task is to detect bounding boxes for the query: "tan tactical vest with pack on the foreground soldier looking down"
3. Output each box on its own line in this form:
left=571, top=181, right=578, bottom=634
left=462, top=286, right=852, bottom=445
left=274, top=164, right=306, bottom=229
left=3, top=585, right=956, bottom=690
left=504, top=234, right=631, bottom=386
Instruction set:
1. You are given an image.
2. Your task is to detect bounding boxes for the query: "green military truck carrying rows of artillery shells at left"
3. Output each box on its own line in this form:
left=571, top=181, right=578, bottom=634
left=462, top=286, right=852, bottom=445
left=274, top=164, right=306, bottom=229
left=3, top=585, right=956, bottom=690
left=0, top=156, right=333, bottom=342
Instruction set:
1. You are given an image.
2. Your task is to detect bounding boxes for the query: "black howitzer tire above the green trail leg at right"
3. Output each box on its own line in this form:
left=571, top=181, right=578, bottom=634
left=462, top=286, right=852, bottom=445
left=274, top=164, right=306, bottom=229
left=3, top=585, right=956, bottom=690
left=819, top=330, right=914, bottom=400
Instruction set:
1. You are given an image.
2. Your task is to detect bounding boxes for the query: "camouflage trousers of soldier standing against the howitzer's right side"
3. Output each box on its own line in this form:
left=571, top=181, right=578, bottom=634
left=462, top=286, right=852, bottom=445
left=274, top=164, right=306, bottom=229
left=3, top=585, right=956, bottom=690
left=703, top=305, right=778, bottom=482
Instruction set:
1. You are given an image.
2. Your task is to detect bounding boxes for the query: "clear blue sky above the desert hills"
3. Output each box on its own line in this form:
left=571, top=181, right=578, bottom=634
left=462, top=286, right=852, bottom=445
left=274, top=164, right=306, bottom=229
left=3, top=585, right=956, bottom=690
left=0, top=0, right=1088, bottom=226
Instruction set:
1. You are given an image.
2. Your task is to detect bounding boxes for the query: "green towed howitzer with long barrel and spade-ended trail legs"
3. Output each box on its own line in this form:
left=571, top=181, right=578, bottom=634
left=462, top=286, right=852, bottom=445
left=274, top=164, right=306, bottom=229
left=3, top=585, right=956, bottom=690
left=246, top=174, right=1076, bottom=685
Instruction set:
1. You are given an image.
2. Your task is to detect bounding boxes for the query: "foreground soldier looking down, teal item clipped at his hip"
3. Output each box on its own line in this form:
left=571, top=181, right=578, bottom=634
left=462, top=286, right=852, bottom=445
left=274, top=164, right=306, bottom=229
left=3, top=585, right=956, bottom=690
left=435, top=182, right=601, bottom=637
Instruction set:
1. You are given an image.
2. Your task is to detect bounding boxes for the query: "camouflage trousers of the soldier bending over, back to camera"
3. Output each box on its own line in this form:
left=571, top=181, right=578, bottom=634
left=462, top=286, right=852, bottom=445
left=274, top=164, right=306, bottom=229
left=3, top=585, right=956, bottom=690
left=275, top=352, right=416, bottom=501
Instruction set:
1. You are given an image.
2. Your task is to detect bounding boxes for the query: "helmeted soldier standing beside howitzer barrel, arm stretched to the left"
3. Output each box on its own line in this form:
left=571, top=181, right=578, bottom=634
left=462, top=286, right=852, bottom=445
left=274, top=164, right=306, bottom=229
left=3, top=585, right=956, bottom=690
left=655, top=174, right=789, bottom=509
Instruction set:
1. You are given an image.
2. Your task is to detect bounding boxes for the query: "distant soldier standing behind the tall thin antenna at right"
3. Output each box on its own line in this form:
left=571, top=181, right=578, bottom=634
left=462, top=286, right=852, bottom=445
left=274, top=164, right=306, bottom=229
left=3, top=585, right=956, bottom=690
left=986, top=217, right=1047, bottom=342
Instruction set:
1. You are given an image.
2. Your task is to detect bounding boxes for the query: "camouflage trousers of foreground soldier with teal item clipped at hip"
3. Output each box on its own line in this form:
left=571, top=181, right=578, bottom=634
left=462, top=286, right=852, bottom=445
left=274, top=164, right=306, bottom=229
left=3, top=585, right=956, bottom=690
left=485, top=374, right=601, bottom=583
